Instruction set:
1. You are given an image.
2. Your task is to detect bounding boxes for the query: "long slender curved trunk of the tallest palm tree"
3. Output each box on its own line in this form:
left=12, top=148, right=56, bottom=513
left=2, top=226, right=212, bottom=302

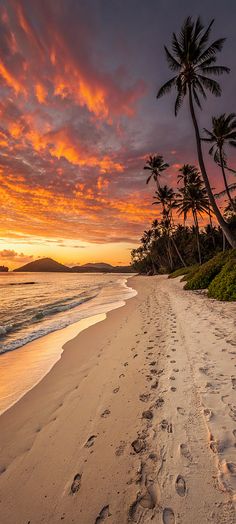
left=188, top=84, right=236, bottom=247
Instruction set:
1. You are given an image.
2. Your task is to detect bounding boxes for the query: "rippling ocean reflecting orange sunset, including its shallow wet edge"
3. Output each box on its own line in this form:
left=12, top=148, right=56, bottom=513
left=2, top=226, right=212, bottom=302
left=0, top=273, right=136, bottom=413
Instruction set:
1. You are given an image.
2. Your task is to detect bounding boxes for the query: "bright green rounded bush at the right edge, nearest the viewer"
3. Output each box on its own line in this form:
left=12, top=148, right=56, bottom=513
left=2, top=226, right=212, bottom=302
left=208, top=256, right=236, bottom=300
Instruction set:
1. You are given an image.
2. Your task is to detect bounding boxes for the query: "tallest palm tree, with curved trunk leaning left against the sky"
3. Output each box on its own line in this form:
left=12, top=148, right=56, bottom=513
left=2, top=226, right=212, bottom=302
left=157, top=17, right=236, bottom=247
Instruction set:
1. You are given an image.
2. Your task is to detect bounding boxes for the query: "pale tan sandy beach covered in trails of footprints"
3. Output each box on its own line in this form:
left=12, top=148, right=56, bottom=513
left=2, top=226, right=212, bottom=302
left=0, top=276, right=236, bottom=524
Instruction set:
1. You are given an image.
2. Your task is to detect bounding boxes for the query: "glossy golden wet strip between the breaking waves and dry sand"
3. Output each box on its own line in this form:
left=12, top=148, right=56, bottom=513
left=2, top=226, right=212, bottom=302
left=0, top=277, right=135, bottom=416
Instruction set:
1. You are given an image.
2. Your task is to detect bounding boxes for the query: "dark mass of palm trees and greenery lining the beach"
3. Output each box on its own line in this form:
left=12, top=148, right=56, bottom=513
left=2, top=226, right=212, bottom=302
left=131, top=17, right=236, bottom=300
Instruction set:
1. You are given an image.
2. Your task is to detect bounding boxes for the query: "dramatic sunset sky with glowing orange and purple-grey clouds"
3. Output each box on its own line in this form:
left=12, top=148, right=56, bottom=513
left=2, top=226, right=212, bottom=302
left=0, top=0, right=236, bottom=269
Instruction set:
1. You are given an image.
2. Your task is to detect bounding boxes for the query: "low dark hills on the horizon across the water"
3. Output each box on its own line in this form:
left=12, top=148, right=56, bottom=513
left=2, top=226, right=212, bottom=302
left=14, top=258, right=133, bottom=273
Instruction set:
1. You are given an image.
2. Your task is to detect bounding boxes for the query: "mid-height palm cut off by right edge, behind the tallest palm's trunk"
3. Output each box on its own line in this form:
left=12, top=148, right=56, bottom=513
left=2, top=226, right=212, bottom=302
left=202, top=113, right=236, bottom=211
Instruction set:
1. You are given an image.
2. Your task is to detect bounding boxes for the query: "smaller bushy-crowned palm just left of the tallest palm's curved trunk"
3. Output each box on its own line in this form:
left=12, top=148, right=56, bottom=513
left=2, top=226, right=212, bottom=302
left=177, top=174, right=209, bottom=264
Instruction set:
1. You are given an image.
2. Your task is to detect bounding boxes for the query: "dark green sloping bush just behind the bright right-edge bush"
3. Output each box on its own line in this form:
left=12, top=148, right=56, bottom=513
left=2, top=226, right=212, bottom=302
left=184, top=250, right=236, bottom=289
